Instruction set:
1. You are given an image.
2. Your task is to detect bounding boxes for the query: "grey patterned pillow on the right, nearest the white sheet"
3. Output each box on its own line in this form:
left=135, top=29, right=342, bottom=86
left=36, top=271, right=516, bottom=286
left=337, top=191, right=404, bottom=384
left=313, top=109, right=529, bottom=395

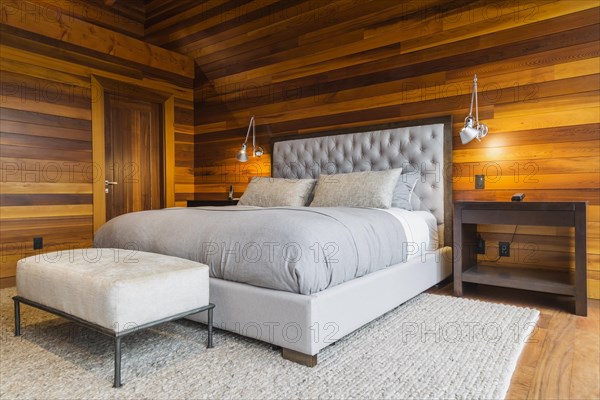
left=310, top=168, right=402, bottom=208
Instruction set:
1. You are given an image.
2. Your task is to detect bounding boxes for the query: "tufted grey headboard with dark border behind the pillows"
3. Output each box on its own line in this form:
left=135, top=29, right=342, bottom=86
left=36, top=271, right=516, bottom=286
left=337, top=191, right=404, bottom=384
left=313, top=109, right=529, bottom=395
left=271, top=117, right=452, bottom=247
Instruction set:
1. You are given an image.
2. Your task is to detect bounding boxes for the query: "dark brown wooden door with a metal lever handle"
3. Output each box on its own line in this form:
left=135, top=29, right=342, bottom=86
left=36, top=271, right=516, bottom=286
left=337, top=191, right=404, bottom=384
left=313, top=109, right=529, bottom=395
left=104, top=93, right=164, bottom=221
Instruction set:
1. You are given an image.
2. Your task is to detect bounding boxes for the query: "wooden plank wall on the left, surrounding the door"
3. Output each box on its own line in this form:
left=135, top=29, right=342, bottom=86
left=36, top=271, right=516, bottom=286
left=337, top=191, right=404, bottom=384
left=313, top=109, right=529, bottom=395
left=0, top=1, right=194, bottom=277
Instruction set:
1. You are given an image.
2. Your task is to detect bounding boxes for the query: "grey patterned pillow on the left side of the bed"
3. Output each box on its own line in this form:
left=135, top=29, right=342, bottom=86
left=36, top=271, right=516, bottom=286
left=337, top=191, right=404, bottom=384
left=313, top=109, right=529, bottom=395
left=238, top=177, right=316, bottom=207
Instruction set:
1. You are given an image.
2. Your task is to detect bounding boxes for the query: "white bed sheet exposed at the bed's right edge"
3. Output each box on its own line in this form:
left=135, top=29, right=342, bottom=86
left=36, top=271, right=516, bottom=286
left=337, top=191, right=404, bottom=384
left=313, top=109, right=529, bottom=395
left=382, top=208, right=439, bottom=260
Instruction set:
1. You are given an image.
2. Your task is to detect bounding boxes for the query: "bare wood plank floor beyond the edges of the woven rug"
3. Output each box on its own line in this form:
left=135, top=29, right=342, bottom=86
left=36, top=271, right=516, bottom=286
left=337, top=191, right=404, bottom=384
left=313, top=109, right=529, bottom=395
left=0, top=278, right=600, bottom=400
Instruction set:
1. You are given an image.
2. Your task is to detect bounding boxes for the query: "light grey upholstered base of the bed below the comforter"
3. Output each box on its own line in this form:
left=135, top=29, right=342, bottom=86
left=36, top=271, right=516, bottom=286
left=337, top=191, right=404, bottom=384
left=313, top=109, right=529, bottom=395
left=188, top=247, right=452, bottom=355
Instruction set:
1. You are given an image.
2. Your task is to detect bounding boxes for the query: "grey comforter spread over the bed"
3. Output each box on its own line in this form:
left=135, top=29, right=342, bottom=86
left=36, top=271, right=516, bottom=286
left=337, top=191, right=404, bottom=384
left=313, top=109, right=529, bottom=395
left=94, top=206, right=406, bottom=294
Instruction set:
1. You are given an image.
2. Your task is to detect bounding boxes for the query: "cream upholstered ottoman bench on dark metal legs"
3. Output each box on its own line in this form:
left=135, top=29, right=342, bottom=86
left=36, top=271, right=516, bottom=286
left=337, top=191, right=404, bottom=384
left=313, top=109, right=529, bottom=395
left=13, top=248, right=214, bottom=387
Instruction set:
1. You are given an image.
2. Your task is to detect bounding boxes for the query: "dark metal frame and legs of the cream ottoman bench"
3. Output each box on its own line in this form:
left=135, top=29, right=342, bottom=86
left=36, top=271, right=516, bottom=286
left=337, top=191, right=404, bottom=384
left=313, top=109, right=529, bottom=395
left=13, top=296, right=215, bottom=388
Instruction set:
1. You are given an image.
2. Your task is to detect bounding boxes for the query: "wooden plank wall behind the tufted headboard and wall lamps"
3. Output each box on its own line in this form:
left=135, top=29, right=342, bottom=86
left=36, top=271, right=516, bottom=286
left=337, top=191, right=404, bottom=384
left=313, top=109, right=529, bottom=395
left=146, top=0, right=600, bottom=298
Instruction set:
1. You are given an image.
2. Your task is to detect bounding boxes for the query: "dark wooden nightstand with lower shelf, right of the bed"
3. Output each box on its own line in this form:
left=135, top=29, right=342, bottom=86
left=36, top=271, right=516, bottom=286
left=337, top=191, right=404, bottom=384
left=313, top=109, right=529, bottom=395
left=454, top=202, right=587, bottom=316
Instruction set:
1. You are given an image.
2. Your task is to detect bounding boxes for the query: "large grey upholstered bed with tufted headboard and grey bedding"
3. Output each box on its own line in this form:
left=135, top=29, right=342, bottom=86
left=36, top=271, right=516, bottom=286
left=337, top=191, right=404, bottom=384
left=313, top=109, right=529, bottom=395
left=94, top=117, right=452, bottom=366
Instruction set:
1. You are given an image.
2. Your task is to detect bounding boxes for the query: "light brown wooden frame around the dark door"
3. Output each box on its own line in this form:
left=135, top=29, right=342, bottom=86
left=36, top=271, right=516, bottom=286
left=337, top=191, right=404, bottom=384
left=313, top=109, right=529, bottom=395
left=91, top=75, right=175, bottom=233
